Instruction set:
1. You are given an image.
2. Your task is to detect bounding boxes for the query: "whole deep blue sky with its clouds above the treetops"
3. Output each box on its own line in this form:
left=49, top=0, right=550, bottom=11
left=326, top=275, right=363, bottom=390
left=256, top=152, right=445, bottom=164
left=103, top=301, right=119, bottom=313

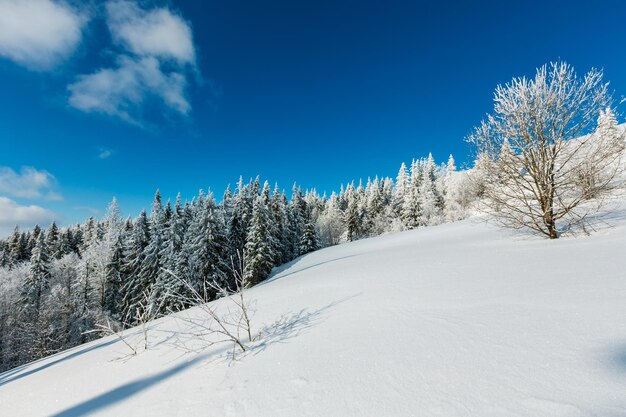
left=0, top=0, right=626, bottom=235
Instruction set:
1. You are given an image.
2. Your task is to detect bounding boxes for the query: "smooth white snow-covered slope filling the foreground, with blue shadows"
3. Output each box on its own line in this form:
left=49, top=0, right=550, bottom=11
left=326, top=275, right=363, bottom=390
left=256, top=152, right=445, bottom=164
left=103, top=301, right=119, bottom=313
left=0, top=221, right=626, bottom=417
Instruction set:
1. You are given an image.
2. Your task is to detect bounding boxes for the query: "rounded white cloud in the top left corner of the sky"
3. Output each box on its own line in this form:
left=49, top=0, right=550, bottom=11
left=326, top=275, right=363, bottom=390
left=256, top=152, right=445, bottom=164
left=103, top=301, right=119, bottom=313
left=0, top=0, right=87, bottom=70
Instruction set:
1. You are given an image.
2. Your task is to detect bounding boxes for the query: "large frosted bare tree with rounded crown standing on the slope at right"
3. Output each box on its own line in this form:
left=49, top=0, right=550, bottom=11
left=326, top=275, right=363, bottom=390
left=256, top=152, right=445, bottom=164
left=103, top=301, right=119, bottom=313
left=467, top=62, right=624, bottom=239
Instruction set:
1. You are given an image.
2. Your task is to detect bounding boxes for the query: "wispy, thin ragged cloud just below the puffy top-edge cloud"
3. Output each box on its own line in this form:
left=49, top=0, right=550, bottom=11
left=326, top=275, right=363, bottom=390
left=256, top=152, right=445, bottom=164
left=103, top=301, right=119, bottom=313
left=68, top=56, right=191, bottom=123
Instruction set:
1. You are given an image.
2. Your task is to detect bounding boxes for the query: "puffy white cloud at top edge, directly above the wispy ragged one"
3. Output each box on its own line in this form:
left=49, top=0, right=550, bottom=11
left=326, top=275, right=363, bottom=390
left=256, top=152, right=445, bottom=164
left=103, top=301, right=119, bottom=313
left=106, top=1, right=196, bottom=64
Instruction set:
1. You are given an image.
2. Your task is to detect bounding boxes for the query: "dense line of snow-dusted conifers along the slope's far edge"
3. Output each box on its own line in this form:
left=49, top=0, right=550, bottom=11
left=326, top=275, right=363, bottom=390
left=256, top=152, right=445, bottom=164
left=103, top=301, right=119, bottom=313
left=0, top=155, right=476, bottom=371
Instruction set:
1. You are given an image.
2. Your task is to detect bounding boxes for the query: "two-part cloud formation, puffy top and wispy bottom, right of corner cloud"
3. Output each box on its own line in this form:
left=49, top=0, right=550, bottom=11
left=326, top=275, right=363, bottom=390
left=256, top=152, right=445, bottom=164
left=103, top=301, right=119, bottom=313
left=68, top=0, right=196, bottom=125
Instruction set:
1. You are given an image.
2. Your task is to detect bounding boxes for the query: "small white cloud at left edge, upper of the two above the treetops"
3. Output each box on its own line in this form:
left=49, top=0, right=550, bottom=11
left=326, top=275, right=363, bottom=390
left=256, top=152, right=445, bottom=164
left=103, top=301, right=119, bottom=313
left=0, top=166, right=63, bottom=201
